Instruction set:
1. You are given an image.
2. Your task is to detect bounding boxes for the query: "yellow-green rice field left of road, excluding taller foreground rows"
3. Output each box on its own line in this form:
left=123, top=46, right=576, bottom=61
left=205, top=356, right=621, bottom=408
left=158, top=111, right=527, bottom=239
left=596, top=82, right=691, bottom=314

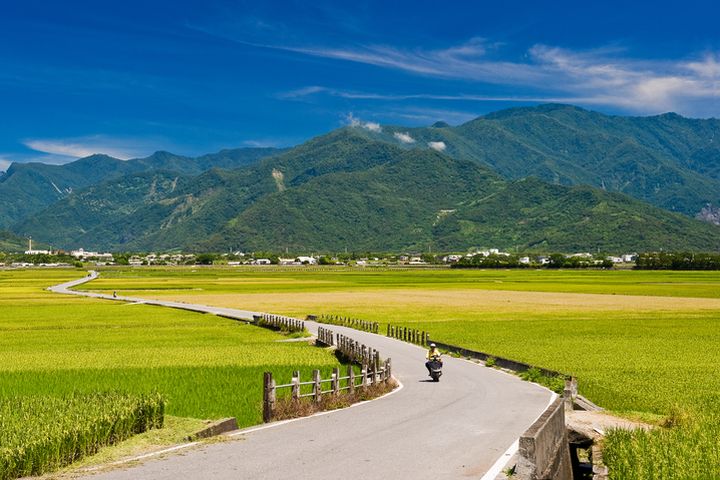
left=0, top=270, right=346, bottom=426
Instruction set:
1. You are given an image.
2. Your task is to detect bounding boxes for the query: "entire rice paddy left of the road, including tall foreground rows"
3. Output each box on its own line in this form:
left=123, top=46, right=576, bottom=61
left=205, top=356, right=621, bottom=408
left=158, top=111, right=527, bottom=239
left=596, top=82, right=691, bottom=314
left=0, top=269, right=348, bottom=478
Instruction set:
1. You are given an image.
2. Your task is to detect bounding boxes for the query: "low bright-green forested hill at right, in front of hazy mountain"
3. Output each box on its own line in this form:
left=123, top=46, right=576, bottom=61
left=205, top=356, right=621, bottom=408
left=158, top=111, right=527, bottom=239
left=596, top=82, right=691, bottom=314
left=434, top=178, right=720, bottom=252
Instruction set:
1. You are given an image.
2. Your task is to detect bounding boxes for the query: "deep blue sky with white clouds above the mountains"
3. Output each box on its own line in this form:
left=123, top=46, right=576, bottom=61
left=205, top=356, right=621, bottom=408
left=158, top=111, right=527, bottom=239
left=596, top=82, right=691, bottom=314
left=0, top=0, right=720, bottom=170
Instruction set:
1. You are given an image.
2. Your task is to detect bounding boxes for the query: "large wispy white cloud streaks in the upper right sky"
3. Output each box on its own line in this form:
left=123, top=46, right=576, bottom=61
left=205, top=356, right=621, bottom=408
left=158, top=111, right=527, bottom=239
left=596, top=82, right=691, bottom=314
left=268, top=40, right=720, bottom=115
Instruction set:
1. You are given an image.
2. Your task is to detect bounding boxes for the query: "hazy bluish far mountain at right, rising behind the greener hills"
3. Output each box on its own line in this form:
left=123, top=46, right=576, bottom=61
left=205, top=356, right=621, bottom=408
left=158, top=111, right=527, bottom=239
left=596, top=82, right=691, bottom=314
left=366, top=104, right=720, bottom=216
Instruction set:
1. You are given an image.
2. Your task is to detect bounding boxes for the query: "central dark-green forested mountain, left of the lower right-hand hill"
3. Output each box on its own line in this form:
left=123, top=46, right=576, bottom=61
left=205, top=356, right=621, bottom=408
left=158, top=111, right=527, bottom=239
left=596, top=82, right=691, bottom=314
left=205, top=150, right=504, bottom=250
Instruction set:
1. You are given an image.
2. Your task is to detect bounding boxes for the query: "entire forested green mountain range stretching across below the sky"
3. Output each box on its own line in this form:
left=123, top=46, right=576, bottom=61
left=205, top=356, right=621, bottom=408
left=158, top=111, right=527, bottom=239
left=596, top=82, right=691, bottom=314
left=0, top=104, right=720, bottom=251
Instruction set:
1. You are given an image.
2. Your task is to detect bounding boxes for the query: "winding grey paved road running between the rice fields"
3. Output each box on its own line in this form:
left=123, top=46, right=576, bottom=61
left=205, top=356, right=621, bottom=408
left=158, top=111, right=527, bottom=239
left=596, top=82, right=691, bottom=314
left=51, top=273, right=553, bottom=480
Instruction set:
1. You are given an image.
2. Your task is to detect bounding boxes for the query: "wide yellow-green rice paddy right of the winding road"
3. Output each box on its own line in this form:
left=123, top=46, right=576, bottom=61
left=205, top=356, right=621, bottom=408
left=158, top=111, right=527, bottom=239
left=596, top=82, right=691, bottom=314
left=85, top=267, right=720, bottom=478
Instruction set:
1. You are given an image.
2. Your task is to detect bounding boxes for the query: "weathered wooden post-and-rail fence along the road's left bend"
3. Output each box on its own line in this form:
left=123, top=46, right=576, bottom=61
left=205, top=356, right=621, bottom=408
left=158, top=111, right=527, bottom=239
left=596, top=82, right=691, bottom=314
left=263, top=327, right=392, bottom=422
